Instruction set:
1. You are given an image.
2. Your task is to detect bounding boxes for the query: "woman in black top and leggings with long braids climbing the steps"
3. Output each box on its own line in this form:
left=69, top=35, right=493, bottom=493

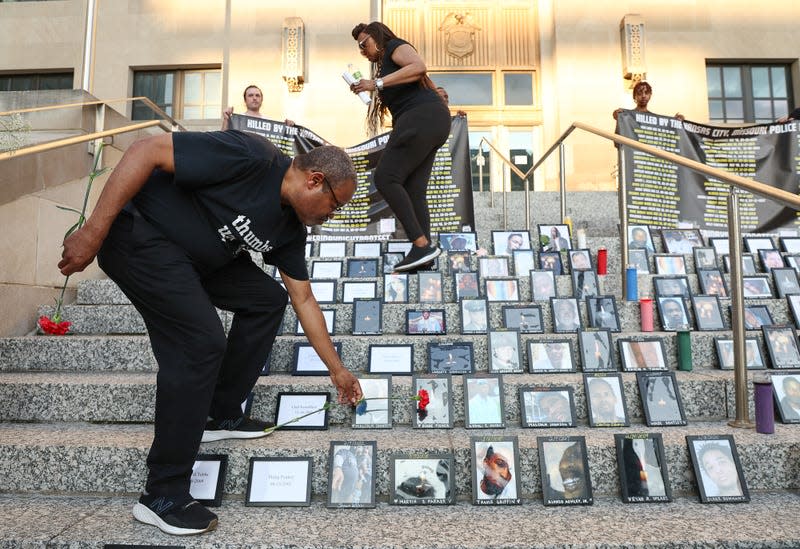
left=350, top=21, right=450, bottom=271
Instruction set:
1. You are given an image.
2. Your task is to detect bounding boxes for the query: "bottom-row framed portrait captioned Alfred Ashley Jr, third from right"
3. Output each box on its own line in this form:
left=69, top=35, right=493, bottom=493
left=536, top=436, right=594, bottom=505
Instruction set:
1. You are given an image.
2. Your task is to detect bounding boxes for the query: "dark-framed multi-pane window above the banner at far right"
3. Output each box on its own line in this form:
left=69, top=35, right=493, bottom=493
left=706, top=63, right=792, bottom=123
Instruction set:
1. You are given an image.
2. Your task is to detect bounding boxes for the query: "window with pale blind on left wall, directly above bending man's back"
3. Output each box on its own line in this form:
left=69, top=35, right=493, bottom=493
left=131, top=69, right=222, bottom=120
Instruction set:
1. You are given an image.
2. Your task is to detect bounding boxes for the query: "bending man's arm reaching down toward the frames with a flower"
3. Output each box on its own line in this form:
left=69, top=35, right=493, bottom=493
left=281, top=271, right=363, bottom=404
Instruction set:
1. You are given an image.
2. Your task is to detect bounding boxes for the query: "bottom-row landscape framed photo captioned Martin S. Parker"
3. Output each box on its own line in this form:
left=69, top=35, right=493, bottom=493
left=389, top=453, right=455, bottom=505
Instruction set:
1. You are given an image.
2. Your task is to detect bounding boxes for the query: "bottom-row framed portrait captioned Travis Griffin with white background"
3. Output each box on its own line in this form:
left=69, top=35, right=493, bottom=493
left=470, top=437, right=522, bottom=505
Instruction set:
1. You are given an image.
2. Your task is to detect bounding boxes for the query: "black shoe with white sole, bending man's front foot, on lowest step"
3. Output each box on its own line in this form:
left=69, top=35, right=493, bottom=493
left=133, top=494, right=217, bottom=536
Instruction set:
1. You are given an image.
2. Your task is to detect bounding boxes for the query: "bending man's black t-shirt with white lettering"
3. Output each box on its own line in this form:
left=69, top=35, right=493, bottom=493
left=133, top=130, right=308, bottom=280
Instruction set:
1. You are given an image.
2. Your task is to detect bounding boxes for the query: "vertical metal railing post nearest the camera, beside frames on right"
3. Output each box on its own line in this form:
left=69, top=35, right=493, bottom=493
left=728, top=192, right=755, bottom=429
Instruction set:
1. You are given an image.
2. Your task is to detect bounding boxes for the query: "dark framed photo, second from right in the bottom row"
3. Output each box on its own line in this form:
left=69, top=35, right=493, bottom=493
left=614, top=433, right=672, bottom=503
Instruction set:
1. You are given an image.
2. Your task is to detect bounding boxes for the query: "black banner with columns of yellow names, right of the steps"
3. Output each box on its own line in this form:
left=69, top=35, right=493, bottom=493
left=617, top=111, right=800, bottom=233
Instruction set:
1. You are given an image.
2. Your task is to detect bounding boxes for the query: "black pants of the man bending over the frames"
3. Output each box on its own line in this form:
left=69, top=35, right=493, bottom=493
left=98, top=211, right=287, bottom=496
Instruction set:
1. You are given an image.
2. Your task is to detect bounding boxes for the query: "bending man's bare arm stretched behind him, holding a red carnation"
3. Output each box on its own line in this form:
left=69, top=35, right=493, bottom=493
left=58, top=134, right=175, bottom=275
